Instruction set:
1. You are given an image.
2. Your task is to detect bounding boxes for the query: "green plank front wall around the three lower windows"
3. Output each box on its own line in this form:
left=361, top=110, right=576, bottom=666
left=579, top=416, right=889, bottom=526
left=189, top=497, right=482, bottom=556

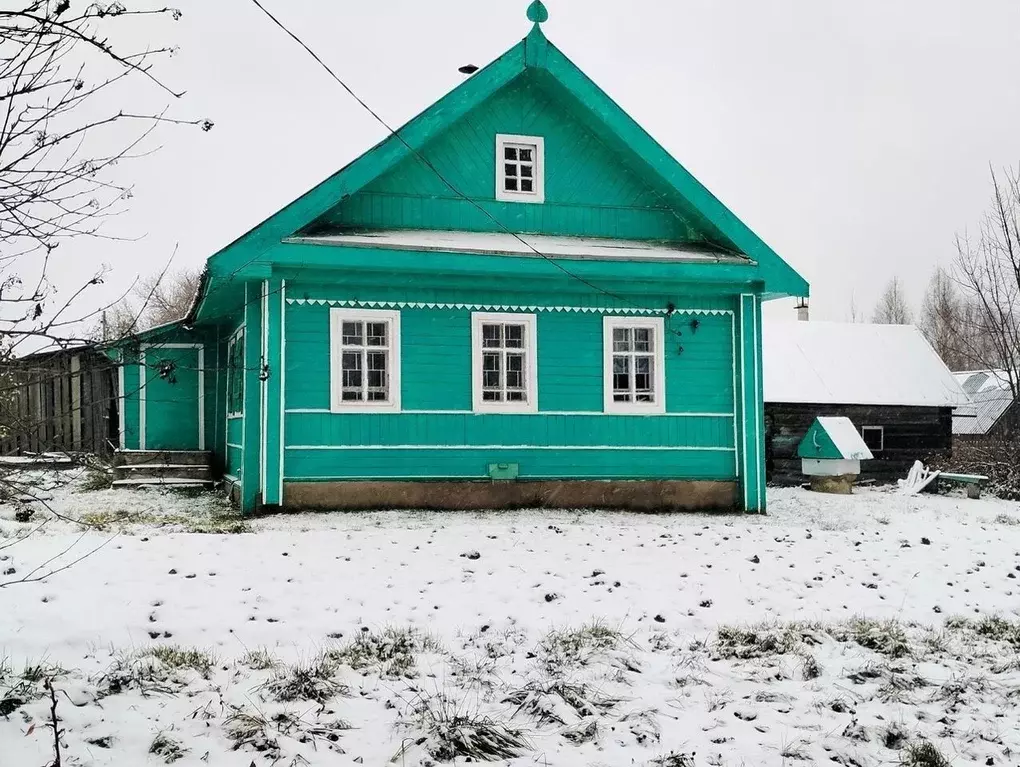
left=284, top=285, right=736, bottom=480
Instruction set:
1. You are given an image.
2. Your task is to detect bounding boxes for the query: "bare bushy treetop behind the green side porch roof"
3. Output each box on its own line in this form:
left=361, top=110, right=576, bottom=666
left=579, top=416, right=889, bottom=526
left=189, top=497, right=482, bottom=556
left=99, top=268, right=202, bottom=341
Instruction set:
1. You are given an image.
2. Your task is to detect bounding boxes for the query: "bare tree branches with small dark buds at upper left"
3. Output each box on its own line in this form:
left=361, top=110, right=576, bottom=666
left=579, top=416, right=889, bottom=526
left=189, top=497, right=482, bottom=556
left=0, top=0, right=212, bottom=356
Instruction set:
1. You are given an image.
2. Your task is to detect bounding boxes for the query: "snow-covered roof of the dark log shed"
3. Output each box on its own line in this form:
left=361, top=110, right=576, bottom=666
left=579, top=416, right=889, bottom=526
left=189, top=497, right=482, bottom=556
left=762, top=321, right=969, bottom=407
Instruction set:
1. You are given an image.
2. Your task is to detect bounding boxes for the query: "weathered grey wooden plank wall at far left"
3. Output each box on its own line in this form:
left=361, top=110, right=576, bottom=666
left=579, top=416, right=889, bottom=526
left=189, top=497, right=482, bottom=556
left=0, top=351, right=118, bottom=456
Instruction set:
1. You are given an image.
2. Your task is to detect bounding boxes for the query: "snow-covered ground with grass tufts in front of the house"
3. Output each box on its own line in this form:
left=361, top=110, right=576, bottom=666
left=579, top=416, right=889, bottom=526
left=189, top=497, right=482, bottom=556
left=0, top=471, right=1020, bottom=767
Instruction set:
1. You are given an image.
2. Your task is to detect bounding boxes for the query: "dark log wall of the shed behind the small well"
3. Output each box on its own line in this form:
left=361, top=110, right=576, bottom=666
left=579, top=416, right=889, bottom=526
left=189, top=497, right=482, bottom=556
left=765, top=402, right=953, bottom=484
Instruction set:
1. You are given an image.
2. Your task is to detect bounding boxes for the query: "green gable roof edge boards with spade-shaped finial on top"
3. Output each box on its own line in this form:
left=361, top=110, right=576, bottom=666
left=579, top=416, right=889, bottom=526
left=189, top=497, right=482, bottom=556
left=189, top=14, right=809, bottom=320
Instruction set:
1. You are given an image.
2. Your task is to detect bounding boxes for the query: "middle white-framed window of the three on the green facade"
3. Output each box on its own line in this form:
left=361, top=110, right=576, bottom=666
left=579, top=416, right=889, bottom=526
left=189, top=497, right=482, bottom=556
left=471, top=312, right=539, bottom=413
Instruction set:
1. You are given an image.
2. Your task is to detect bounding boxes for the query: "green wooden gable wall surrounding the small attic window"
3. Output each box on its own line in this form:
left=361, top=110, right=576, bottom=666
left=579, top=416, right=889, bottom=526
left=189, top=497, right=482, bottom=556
left=317, top=74, right=705, bottom=241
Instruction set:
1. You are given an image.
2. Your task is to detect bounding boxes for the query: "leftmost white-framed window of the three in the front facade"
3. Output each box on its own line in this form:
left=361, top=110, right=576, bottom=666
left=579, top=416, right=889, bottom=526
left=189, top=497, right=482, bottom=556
left=329, top=308, right=400, bottom=413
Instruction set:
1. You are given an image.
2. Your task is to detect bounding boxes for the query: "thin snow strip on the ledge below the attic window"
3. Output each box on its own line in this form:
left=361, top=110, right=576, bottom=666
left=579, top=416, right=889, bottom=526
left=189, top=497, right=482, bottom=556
left=287, top=229, right=750, bottom=263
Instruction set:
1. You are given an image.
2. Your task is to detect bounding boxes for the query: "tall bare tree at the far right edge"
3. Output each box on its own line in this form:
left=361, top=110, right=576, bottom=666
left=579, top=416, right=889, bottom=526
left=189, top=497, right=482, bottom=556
left=955, top=168, right=1020, bottom=407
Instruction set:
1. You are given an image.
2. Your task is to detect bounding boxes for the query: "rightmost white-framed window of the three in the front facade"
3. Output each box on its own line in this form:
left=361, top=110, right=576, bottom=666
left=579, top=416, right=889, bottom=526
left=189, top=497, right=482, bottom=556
left=603, top=317, right=666, bottom=413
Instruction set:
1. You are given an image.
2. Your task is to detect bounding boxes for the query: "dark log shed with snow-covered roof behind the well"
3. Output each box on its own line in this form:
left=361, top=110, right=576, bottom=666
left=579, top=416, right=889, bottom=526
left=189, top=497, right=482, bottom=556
left=762, top=321, right=969, bottom=484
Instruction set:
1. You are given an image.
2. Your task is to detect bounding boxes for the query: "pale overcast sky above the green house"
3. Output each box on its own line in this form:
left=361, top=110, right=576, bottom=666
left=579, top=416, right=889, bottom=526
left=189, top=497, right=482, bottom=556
left=43, top=0, right=1020, bottom=319
